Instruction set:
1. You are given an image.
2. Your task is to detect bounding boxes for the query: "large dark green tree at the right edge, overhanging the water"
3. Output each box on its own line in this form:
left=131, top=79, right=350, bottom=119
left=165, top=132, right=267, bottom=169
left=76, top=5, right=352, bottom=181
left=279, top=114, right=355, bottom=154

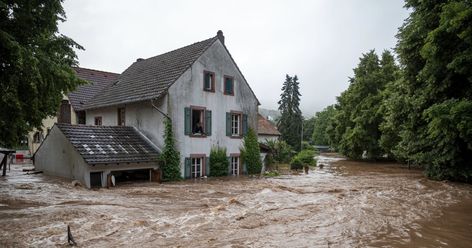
left=390, top=0, right=472, bottom=182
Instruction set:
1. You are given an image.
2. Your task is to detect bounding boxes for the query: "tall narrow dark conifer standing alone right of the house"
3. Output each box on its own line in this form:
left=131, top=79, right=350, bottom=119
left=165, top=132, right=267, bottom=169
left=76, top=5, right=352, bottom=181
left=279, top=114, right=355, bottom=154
left=277, top=75, right=303, bottom=151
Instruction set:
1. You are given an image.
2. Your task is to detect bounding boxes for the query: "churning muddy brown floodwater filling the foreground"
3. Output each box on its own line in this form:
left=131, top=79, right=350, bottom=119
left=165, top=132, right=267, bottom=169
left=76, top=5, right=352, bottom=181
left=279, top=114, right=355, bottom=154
left=0, top=156, right=472, bottom=247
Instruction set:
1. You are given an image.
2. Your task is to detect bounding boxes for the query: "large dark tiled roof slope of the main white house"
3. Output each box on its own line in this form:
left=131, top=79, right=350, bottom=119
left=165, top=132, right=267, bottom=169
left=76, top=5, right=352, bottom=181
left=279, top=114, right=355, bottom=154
left=86, top=36, right=218, bottom=109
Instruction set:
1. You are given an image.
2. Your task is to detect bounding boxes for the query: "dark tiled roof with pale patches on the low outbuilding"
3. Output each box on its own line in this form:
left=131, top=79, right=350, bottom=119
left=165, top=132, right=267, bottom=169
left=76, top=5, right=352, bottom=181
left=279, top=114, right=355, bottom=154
left=56, top=123, right=159, bottom=165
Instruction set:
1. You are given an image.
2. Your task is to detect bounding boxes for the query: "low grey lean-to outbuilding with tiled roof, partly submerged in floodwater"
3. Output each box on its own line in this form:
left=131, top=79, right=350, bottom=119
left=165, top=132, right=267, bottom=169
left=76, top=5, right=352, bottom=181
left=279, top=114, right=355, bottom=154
left=34, top=124, right=160, bottom=188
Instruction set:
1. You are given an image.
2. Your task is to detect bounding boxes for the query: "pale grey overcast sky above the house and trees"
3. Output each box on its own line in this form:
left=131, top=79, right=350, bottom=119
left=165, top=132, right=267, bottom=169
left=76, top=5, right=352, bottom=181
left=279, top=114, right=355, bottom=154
left=60, top=0, right=408, bottom=116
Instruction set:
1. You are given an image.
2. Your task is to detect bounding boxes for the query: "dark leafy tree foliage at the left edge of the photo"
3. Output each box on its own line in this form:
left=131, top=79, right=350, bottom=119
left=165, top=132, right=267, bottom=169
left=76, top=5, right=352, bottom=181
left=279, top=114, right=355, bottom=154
left=0, top=0, right=84, bottom=147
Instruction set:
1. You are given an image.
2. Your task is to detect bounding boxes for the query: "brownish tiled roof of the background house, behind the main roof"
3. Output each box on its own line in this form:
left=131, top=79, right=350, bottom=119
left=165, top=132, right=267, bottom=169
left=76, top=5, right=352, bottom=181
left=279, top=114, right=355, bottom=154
left=67, top=67, right=120, bottom=111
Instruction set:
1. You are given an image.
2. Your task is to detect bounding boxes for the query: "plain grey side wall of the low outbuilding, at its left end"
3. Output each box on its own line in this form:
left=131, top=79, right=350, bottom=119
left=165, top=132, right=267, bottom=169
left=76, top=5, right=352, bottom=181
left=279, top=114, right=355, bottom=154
left=34, top=126, right=90, bottom=185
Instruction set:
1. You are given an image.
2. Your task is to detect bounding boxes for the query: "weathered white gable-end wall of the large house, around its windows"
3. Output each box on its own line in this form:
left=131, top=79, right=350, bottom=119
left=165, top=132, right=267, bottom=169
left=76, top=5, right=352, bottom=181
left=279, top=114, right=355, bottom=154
left=167, top=41, right=258, bottom=176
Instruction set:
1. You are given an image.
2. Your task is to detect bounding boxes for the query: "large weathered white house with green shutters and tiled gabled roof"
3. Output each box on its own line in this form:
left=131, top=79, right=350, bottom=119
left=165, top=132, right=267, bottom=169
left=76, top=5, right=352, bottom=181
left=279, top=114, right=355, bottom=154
left=35, top=31, right=259, bottom=183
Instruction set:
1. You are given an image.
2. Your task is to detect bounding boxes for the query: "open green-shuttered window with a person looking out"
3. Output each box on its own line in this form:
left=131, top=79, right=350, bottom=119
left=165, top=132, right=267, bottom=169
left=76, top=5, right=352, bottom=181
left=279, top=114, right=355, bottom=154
left=184, top=107, right=212, bottom=137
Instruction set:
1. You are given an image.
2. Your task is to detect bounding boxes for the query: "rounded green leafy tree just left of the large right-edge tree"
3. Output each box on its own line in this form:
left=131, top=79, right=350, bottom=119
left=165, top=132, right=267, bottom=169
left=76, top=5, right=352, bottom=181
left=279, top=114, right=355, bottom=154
left=334, top=50, right=399, bottom=159
